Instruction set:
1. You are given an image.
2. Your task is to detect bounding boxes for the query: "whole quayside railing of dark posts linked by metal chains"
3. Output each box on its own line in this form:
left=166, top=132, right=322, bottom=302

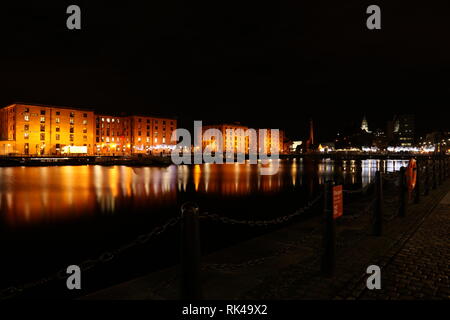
left=0, top=158, right=450, bottom=300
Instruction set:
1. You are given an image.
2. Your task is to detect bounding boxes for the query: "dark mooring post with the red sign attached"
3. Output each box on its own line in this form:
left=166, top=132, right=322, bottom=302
left=322, top=181, right=336, bottom=277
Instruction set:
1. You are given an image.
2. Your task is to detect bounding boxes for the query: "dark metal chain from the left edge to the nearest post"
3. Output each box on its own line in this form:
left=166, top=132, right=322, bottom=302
left=0, top=216, right=181, bottom=300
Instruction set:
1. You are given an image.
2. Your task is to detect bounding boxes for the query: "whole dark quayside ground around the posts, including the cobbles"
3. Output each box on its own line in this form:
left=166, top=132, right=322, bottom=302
left=85, top=181, right=450, bottom=299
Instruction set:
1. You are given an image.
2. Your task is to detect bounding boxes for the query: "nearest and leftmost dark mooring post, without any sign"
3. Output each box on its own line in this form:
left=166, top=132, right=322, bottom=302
left=181, top=202, right=202, bottom=300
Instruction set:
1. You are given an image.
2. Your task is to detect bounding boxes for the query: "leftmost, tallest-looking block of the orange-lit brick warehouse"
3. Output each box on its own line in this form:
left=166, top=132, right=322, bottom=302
left=0, top=104, right=94, bottom=155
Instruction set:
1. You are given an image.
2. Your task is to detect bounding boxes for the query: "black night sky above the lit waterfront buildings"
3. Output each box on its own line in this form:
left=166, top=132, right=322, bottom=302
left=0, top=0, right=450, bottom=139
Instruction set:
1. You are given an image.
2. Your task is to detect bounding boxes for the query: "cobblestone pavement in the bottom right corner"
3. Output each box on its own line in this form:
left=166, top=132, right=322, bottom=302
left=360, top=203, right=450, bottom=299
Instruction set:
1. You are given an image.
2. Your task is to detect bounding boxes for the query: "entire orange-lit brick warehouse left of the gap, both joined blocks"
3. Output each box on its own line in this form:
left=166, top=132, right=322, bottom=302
left=0, top=104, right=177, bottom=155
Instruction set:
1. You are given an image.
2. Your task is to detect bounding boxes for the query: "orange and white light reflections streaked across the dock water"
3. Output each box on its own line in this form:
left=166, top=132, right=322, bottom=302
left=0, top=159, right=407, bottom=226
